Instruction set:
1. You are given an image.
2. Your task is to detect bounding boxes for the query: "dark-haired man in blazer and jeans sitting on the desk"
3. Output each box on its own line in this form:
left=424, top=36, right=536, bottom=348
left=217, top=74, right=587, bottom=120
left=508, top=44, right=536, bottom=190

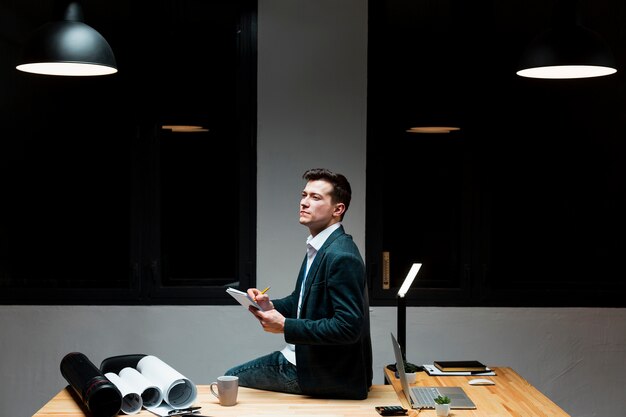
left=226, top=169, right=372, bottom=399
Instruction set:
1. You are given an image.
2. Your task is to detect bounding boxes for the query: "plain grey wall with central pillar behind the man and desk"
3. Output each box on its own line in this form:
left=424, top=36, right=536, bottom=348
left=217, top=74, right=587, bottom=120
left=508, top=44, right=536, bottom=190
left=0, top=0, right=626, bottom=417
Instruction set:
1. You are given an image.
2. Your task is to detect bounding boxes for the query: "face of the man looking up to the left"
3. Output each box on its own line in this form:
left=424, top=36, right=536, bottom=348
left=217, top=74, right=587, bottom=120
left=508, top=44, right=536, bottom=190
left=300, top=180, right=344, bottom=236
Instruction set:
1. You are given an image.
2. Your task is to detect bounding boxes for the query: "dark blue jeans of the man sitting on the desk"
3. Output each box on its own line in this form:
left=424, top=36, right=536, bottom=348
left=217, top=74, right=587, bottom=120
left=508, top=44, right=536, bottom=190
left=224, top=351, right=302, bottom=394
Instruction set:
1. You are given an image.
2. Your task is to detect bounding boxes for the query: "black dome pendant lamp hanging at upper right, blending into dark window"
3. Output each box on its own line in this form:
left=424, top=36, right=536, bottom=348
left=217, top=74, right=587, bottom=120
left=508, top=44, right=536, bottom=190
left=517, top=0, right=617, bottom=79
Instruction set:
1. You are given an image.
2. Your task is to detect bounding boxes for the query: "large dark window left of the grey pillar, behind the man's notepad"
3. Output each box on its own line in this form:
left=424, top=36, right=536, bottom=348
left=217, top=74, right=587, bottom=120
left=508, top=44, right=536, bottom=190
left=0, top=0, right=256, bottom=304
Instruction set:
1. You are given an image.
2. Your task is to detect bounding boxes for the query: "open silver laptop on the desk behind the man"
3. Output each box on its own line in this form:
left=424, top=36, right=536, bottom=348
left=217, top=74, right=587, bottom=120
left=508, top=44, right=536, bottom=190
left=391, top=333, right=476, bottom=410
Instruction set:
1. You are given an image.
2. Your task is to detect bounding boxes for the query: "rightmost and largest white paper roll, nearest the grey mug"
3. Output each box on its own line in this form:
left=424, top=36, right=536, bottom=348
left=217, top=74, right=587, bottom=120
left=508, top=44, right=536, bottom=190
left=137, top=355, right=198, bottom=408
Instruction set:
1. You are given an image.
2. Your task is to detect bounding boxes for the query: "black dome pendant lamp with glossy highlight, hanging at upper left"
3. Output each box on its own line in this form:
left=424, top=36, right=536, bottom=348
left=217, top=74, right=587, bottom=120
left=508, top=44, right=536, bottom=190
left=16, top=2, right=117, bottom=76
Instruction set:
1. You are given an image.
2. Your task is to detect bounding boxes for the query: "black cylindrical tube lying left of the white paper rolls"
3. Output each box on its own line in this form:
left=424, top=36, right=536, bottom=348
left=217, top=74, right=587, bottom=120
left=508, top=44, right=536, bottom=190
left=61, top=352, right=122, bottom=417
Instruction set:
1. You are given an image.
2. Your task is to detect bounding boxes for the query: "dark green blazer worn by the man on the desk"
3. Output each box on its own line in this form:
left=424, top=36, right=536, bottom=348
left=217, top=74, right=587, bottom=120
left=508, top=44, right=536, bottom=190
left=272, top=226, right=373, bottom=399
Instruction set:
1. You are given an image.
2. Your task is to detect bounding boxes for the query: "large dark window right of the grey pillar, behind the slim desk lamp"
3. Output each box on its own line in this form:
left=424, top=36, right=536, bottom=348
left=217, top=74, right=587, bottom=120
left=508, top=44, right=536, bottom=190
left=366, top=0, right=626, bottom=307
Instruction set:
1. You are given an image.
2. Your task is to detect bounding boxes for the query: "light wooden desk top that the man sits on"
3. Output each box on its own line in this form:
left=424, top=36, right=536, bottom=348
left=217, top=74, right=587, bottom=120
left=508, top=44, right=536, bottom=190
left=33, top=368, right=569, bottom=417
